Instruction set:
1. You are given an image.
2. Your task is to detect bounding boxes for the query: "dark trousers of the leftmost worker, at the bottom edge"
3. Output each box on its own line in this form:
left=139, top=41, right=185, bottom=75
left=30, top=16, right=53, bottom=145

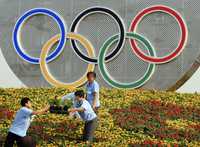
left=4, top=132, right=36, bottom=147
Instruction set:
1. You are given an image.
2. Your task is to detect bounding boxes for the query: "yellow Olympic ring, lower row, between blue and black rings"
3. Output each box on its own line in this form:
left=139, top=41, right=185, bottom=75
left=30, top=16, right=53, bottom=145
left=40, top=33, right=95, bottom=89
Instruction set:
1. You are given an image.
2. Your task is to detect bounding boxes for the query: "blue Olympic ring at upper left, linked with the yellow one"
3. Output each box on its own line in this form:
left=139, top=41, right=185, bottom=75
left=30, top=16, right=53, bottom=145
left=13, top=8, right=66, bottom=64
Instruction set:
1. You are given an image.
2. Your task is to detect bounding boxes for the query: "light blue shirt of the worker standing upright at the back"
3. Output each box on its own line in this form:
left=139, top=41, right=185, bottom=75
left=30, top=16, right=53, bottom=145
left=86, top=81, right=100, bottom=107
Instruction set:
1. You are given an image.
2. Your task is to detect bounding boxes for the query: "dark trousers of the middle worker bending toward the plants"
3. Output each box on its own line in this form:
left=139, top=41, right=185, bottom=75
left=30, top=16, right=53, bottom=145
left=83, top=118, right=98, bottom=141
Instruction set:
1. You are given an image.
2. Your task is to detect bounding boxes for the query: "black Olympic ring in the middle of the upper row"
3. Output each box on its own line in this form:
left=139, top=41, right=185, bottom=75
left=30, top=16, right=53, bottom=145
left=70, top=7, right=125, bottom=64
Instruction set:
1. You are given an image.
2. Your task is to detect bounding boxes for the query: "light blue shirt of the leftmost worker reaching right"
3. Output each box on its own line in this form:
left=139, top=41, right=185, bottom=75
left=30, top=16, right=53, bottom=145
left=9, top=107, right=33, bottom=137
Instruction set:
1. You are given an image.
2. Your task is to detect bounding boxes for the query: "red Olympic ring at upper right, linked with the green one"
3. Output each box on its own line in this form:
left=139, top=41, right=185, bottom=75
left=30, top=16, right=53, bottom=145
left=129, top=5, right=188, bottom=64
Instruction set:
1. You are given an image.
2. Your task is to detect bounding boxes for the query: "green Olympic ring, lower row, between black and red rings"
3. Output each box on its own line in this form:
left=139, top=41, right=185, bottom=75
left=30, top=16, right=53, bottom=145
left=98, top=32, right=156, bottom=88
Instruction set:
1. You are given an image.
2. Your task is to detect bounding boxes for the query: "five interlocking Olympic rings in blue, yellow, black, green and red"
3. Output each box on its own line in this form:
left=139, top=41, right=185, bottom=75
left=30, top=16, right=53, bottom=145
left=12, top=5, right=188, bottom=88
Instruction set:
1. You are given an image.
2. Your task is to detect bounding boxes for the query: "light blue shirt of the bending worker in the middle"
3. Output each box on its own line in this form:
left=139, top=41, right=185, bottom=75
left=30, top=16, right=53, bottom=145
left=78, top=100, right=97, bottom=121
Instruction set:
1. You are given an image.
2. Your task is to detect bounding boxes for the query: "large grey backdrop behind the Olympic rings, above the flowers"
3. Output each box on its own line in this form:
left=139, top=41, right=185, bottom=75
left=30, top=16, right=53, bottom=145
left=0, top=0, right=200, bottom=92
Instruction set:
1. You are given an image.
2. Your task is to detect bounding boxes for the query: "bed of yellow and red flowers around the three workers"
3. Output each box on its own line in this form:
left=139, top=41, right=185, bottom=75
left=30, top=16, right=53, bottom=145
left=0, top=88, right=200, bottom=147
